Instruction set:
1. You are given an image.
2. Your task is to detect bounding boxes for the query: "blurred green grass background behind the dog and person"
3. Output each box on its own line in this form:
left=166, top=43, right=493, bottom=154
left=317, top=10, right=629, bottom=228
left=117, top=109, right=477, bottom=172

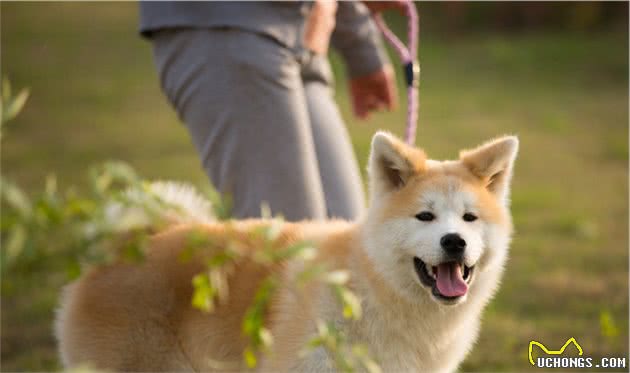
left=0, top=2, right=628, bottom=371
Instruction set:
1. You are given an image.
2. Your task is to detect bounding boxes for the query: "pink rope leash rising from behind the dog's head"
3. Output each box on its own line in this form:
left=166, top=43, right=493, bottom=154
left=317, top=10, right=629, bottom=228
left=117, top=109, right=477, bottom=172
left=374, top=0, right=420, bottom=145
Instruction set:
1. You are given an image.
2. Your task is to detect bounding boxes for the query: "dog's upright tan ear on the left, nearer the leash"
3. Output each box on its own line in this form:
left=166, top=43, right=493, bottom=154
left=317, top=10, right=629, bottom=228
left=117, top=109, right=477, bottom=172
left=368, top=131, right=426, bottom=194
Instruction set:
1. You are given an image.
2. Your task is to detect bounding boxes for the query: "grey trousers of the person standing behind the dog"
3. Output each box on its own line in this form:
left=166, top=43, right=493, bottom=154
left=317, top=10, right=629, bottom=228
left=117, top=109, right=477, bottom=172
left=153, top=28, right=364, bottom=221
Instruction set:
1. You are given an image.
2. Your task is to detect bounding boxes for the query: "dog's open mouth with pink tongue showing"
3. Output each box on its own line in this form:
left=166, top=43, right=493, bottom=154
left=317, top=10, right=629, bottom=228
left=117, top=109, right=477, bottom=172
left=413, top=257, right=475, bottom=303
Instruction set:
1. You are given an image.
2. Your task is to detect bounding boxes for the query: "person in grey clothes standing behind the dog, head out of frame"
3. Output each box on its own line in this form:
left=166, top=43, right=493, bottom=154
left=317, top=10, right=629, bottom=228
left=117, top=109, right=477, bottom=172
left=140, top=0, right=399, bottom=221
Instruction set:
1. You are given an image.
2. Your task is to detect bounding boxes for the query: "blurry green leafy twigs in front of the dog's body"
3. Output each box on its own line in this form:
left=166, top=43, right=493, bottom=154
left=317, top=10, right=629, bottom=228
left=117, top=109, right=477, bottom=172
left=0, top=79, right=380, bottom=372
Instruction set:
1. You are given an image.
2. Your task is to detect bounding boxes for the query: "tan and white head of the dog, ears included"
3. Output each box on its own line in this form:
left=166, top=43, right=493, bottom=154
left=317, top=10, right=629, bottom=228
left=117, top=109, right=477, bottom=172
left=363, top=132, right=518, bottom=305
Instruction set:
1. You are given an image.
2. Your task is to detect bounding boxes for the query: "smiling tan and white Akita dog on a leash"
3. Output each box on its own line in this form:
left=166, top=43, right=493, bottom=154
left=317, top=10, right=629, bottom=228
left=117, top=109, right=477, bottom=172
left=56, top=132, right=518, bottom=372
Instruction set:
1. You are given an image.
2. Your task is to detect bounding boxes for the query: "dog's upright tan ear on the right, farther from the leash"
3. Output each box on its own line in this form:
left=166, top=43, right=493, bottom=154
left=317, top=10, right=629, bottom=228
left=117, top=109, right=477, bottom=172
left=459, top=136, right=518, bottom=204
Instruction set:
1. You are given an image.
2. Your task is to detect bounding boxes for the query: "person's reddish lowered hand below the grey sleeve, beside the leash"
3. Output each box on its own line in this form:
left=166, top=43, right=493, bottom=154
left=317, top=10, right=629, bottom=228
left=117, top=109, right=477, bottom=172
left=350, top=64, right=397, bottom=119
